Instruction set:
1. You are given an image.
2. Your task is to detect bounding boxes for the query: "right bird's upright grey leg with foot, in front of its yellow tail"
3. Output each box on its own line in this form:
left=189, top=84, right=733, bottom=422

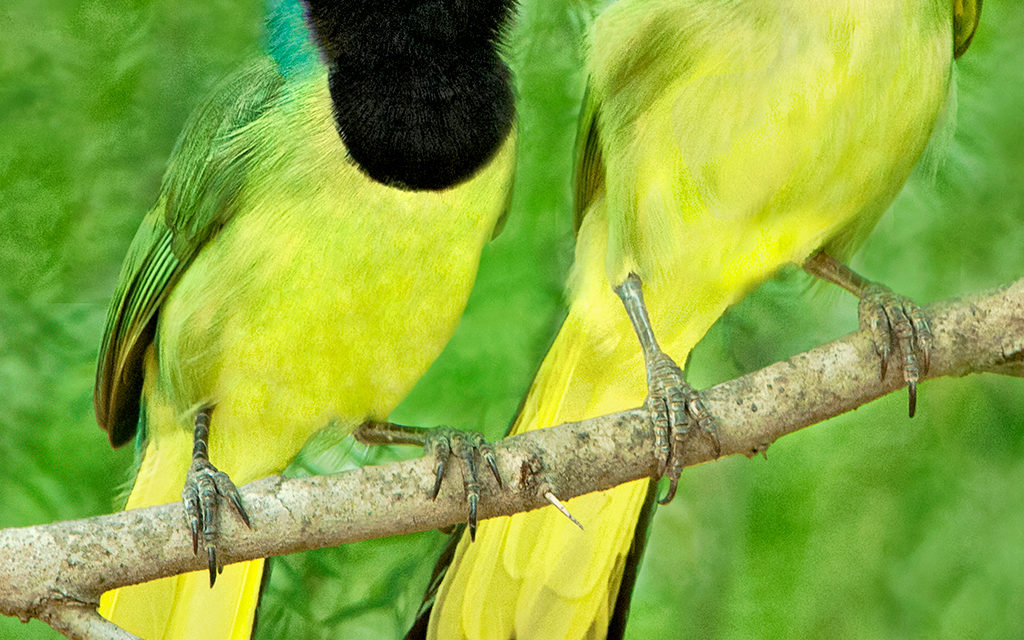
left=615, top=273, right=721, bottom=505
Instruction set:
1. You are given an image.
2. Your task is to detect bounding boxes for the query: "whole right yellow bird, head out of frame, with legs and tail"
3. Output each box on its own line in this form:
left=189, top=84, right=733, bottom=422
left=411, top=0, right=981, bottom=640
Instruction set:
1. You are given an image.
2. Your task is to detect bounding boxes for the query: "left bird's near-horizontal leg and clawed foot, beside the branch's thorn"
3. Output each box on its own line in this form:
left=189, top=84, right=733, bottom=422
left=353, top=421, right=505, bottom=540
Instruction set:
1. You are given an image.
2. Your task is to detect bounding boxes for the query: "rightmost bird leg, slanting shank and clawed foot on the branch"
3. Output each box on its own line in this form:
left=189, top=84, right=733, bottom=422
left=804, top=246, right=932, bottom=418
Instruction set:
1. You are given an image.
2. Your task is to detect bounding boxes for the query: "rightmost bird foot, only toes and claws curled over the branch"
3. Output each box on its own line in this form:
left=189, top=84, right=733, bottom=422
left=857, top=283, right=933, bottom=418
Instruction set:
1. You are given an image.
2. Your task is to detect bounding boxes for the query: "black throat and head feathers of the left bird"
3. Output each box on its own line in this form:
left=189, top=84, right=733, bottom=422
left=307, top=0, right=515, bottom=189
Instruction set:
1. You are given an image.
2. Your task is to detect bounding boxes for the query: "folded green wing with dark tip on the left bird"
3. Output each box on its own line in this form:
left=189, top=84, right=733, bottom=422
left=93, top=59, right=284, bottom=446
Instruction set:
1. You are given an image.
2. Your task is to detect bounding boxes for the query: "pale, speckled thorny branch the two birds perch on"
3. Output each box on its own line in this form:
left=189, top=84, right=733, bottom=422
left=6, top=279, right=1024, bottom=639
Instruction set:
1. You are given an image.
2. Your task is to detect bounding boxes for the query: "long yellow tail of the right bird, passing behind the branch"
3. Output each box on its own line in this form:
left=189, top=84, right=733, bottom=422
left=428, top=312, right=649, bottom=640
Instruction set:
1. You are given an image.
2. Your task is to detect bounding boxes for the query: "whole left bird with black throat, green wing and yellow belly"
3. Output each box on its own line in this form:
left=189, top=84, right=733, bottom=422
left=95, top=0, right=516, bottom=640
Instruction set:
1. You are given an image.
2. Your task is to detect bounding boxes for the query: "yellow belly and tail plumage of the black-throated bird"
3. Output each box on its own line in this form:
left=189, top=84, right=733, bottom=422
left=100, top=66, right=515, bottom=640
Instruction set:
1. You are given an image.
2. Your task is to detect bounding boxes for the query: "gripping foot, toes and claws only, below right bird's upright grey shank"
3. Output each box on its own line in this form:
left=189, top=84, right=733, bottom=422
left=644, top=351, right=722, bottom=505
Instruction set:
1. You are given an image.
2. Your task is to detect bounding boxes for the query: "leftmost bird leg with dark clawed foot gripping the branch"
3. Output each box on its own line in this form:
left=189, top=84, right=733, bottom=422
left=181, top=409, right=252, bottom=587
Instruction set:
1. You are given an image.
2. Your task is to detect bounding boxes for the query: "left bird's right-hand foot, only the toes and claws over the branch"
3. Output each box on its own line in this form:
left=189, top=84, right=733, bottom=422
left=425, top=427, right=505, bottom=540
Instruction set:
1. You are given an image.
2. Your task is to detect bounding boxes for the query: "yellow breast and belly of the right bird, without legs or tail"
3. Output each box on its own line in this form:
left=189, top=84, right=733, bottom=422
left=590, top=0, right=952, bottom=346
